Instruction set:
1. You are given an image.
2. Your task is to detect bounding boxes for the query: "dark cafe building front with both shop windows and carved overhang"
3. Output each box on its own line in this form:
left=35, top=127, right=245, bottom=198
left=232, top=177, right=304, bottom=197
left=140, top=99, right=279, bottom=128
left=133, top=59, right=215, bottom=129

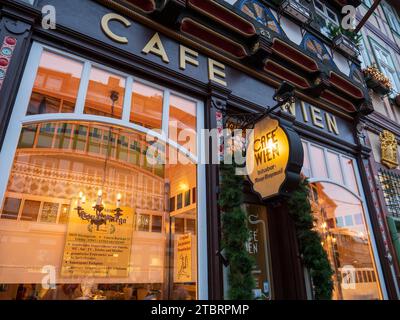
left=0, top=0, right=398, bottom=300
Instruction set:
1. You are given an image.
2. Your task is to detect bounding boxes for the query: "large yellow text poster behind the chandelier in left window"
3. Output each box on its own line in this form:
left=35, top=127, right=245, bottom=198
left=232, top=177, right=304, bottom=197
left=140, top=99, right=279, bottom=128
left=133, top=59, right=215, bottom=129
left=61, top=201, right=134, bottom=278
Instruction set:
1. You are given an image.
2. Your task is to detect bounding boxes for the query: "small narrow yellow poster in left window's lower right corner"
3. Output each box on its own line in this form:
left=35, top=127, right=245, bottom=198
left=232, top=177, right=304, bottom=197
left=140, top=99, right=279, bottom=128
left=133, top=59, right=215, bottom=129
left=175, top=233, right=193, bottom=282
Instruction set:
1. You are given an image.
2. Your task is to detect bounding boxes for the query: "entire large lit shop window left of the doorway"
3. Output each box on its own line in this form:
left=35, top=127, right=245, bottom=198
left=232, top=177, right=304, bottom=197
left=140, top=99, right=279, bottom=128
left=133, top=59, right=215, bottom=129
left=0, top=44, right=204, bottom=300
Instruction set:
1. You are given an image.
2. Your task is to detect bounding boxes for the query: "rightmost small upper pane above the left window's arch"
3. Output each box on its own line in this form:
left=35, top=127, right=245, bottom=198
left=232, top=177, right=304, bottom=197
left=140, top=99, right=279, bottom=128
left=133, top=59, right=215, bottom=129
left=169, top=95, right=197, bottom=154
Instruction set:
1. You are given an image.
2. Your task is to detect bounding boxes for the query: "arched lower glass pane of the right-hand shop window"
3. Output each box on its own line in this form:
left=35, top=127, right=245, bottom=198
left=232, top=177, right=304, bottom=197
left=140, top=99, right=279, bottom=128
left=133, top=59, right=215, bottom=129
left=311, top=182, right=380, bottom=300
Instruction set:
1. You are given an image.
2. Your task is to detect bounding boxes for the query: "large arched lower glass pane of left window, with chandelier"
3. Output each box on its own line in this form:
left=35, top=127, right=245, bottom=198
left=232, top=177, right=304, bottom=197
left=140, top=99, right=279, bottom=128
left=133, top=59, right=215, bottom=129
left=0, top=121, right=197, bottom=300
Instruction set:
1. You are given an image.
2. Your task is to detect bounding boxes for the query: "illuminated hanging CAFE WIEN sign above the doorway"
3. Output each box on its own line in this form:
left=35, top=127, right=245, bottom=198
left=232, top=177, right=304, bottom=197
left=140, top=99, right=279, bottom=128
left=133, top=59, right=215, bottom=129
left=246, top=117, right=304, bottom=199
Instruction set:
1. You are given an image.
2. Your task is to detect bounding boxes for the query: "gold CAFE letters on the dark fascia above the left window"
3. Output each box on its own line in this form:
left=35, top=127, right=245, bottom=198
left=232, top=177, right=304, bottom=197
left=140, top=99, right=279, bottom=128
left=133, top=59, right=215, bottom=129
left=101, top=13, right=227, bottom=86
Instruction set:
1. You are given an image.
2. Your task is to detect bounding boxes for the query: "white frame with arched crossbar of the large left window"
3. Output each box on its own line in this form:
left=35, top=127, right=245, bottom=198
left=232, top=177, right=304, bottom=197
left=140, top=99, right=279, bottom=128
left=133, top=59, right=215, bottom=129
left=0, top=42, right=208, bottom=300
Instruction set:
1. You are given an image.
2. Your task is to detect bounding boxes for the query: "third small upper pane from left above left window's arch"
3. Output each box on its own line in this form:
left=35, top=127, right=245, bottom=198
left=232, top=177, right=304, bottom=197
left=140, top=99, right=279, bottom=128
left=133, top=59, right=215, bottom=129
left=130, top=82, right=164, bottom=129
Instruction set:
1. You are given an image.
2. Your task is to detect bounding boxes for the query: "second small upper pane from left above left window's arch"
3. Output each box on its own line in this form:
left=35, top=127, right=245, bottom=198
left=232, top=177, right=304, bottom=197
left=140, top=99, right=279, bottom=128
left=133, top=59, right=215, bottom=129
left=85, top=67, right=126, bottom=119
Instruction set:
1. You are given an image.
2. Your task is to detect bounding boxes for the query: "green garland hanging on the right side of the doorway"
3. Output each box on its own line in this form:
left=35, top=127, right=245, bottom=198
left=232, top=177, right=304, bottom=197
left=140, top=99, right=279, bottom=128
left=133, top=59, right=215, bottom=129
left=288, top=180, right=333, bottom=300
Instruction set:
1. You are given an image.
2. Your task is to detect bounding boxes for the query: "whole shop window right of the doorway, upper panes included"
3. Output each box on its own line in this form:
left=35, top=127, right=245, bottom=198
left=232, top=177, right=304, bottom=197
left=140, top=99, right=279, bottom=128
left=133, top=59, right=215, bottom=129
left=303, top=141, right=382, bottom=300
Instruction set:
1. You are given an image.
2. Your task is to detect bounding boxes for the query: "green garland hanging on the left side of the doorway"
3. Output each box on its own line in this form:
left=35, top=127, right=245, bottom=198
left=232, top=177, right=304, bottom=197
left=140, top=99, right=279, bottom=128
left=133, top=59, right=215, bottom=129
left=218, top=164, right=255, bottom=300
